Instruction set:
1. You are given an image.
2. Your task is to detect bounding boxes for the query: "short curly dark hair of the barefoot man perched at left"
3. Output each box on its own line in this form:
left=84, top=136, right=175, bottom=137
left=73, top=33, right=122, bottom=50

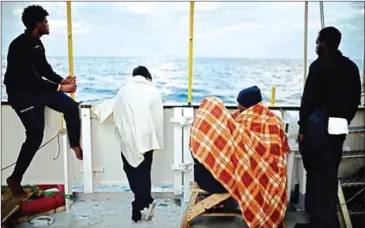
left=22, top=5, right=49, bottom=30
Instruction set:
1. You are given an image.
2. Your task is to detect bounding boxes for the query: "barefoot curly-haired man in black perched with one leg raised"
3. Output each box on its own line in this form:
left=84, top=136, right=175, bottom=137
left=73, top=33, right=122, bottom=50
left=4, top=5, right=82, bottom=196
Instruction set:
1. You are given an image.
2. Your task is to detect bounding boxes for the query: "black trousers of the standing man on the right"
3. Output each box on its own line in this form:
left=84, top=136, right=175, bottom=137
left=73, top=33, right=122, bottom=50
left=299, top=108, right=346, bottom=228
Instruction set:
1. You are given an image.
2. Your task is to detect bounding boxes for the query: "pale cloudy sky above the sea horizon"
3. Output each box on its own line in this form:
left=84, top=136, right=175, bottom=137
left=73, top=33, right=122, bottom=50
left=1, top=2, right=364, bottom=59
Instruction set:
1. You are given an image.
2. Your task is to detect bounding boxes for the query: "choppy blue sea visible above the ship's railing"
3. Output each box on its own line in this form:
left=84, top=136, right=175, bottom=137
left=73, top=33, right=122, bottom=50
left=1, top=56, right=363, bottom=106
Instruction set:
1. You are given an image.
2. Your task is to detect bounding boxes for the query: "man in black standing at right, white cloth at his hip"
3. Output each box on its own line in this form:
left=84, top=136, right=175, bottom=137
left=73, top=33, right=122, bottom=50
left=295, top=27, right=361, bottom=228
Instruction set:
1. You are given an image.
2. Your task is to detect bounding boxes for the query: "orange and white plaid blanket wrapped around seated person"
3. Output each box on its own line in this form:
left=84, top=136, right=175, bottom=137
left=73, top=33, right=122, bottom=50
left=190, top=97, right=289, bottom=228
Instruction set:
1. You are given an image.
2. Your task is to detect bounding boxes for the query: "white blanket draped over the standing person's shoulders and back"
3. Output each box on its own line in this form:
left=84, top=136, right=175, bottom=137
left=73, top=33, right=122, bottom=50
left=112, top=76, right=164, bottom=167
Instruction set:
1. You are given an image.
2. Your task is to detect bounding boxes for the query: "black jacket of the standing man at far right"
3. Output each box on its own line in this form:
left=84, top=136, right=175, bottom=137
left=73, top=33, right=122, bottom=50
left=299, top=51, right=361, bottom=134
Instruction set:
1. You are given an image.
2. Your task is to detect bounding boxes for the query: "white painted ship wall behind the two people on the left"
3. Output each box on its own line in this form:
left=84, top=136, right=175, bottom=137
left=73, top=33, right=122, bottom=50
left=1, top=105, right=173, bottom=186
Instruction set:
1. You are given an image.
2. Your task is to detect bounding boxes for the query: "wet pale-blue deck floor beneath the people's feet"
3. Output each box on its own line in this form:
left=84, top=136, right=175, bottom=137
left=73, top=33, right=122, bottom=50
left=12, top=194, right=305, bottom=228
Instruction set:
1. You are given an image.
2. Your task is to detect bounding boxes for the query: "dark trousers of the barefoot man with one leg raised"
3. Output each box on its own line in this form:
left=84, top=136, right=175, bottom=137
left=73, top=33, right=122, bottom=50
left=9, top=91, right=81, bottom=182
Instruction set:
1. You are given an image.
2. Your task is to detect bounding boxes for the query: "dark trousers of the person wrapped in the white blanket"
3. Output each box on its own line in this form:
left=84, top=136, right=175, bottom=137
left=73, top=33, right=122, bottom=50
left=122, top=150, right=154, bottom=210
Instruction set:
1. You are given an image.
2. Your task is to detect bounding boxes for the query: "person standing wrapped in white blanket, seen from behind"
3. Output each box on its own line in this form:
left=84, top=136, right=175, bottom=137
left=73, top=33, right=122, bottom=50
left=113, top=66, right=164, bottom=222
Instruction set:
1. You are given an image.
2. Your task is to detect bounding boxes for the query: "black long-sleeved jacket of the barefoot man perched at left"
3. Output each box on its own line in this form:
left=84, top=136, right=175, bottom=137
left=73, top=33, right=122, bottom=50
left=4, top=31, right=63, bottom=98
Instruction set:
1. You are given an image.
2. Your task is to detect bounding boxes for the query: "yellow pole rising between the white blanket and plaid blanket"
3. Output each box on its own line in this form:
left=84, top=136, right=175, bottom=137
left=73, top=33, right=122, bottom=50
left=188, top=1, right=195, bottom=105
